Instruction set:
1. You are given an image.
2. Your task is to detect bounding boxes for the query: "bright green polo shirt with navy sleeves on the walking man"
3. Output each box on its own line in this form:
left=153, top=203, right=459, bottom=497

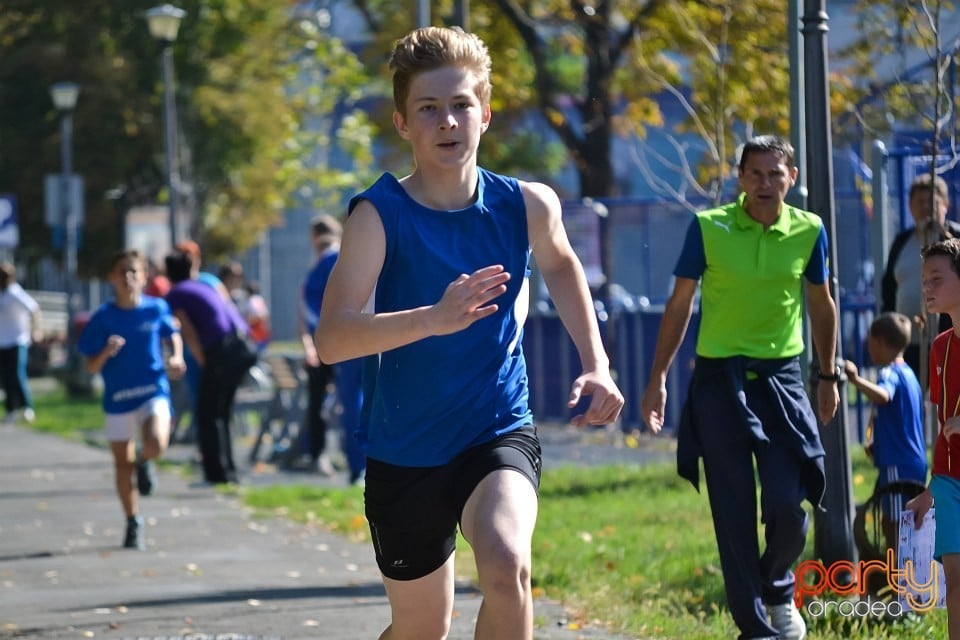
left=674, top=194, right=827, bottom=358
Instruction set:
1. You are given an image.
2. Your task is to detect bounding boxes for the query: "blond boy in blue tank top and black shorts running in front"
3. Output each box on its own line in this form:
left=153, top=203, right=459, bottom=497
left=315, top=27, right=623, bottom=640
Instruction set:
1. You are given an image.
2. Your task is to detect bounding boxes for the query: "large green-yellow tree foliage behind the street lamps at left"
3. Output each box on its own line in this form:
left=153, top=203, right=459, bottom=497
left=0, top=0, right=375, bottom=273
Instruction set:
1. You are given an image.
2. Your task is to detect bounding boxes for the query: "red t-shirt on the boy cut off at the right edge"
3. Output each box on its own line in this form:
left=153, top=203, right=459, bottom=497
left=930, top=329, right=960, bottom=480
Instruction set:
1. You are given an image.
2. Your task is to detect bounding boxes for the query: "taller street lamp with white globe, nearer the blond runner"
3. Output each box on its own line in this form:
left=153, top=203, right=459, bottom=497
left=146, top=4, right=187, bottom=247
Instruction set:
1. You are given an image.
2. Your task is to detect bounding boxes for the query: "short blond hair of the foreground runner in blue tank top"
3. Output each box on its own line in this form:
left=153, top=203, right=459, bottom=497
left=390, top=27, right=492, bottom=117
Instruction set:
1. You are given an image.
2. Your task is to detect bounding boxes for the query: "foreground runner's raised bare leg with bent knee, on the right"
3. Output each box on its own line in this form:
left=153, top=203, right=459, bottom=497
left=462, top=469, right=537, bottom=640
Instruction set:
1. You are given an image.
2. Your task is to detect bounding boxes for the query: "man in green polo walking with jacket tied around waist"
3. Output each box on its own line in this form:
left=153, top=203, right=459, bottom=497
left=641, top=136, right=839, bottom=639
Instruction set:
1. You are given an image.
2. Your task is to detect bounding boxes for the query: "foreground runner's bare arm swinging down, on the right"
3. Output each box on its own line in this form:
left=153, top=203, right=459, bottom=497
left=521, top=182, right=624, bottom=426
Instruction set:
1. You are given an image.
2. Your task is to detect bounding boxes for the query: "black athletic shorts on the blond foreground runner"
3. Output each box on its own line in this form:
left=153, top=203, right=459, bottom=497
left=364, top=425, right=541, bottom=580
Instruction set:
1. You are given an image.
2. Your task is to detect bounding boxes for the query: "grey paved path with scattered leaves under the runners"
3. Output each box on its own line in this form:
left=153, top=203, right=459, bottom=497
left=0, top=425, right=656, bottom=640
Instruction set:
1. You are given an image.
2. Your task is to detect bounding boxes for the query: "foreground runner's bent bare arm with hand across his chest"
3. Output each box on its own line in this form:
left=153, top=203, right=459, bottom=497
left=314, top=201, right=510, bottom=364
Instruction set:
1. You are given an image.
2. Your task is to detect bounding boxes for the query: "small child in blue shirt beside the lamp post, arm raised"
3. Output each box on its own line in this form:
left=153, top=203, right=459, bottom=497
left=844, top=312, right=927, bottom=549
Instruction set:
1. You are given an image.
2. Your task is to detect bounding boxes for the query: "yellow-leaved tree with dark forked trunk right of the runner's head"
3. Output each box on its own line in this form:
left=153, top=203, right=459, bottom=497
left=350, top=0, right=789, bottom=197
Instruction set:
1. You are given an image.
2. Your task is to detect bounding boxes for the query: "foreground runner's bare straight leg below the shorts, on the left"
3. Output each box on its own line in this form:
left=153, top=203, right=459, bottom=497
left=380, top=554, right=455, bottom=640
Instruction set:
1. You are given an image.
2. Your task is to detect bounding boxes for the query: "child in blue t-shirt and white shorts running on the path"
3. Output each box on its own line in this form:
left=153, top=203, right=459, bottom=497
left=77, top=249, right=186, bottom=550
